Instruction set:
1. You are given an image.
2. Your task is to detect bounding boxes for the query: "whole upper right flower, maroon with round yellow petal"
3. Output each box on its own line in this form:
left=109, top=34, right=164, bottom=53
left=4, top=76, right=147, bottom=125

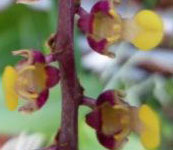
left=78, top=0, right=164, bottom=57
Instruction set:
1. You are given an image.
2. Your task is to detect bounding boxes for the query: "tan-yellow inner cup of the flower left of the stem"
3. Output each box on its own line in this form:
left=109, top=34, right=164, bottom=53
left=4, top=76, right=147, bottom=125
left=16, top=63, right=47, bottom=100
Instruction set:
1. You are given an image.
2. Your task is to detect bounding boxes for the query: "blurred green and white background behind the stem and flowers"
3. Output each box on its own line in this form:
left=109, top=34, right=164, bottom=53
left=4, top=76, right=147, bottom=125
left=0, top=0, right=173, bottom=150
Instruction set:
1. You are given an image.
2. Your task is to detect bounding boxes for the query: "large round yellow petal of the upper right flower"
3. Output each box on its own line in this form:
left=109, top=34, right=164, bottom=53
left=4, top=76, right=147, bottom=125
left=132, top=10, right=164, bottom=50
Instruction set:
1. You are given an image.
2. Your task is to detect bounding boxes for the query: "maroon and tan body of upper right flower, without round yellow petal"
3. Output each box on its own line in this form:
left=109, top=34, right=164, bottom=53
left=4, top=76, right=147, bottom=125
left=78, top=0, right=122, bottom=57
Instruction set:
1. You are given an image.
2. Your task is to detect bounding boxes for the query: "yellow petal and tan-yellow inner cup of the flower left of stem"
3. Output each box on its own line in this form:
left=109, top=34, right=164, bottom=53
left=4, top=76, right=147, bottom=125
left=2, top=63, right=47, bottom=110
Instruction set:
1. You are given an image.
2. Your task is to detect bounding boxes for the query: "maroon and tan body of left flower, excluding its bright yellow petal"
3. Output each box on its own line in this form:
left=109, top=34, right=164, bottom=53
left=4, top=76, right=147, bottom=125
left=9, top=50, right=60, bottom=113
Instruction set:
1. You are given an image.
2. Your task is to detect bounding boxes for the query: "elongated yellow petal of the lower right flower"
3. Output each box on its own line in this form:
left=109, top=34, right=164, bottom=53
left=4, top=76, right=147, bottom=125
left=139, top=105, right=160, bottom=149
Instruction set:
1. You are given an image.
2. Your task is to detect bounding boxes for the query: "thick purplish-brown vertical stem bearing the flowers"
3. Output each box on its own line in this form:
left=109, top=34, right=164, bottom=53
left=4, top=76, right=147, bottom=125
left=53, top=0, right=83, bottom=150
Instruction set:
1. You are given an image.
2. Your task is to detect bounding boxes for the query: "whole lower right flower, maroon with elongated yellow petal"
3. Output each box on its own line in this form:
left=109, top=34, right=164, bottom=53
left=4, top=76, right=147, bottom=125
left=86, top=90, right=160, bottom=150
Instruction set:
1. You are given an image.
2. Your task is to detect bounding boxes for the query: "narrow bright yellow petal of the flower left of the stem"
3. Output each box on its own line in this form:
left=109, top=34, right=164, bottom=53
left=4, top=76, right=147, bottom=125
left=2, top=66, right=18, bottom=111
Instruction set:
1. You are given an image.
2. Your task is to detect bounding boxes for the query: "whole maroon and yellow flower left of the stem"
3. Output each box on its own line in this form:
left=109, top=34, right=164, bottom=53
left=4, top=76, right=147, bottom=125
left=2, top=50, right=60, bottom=113
